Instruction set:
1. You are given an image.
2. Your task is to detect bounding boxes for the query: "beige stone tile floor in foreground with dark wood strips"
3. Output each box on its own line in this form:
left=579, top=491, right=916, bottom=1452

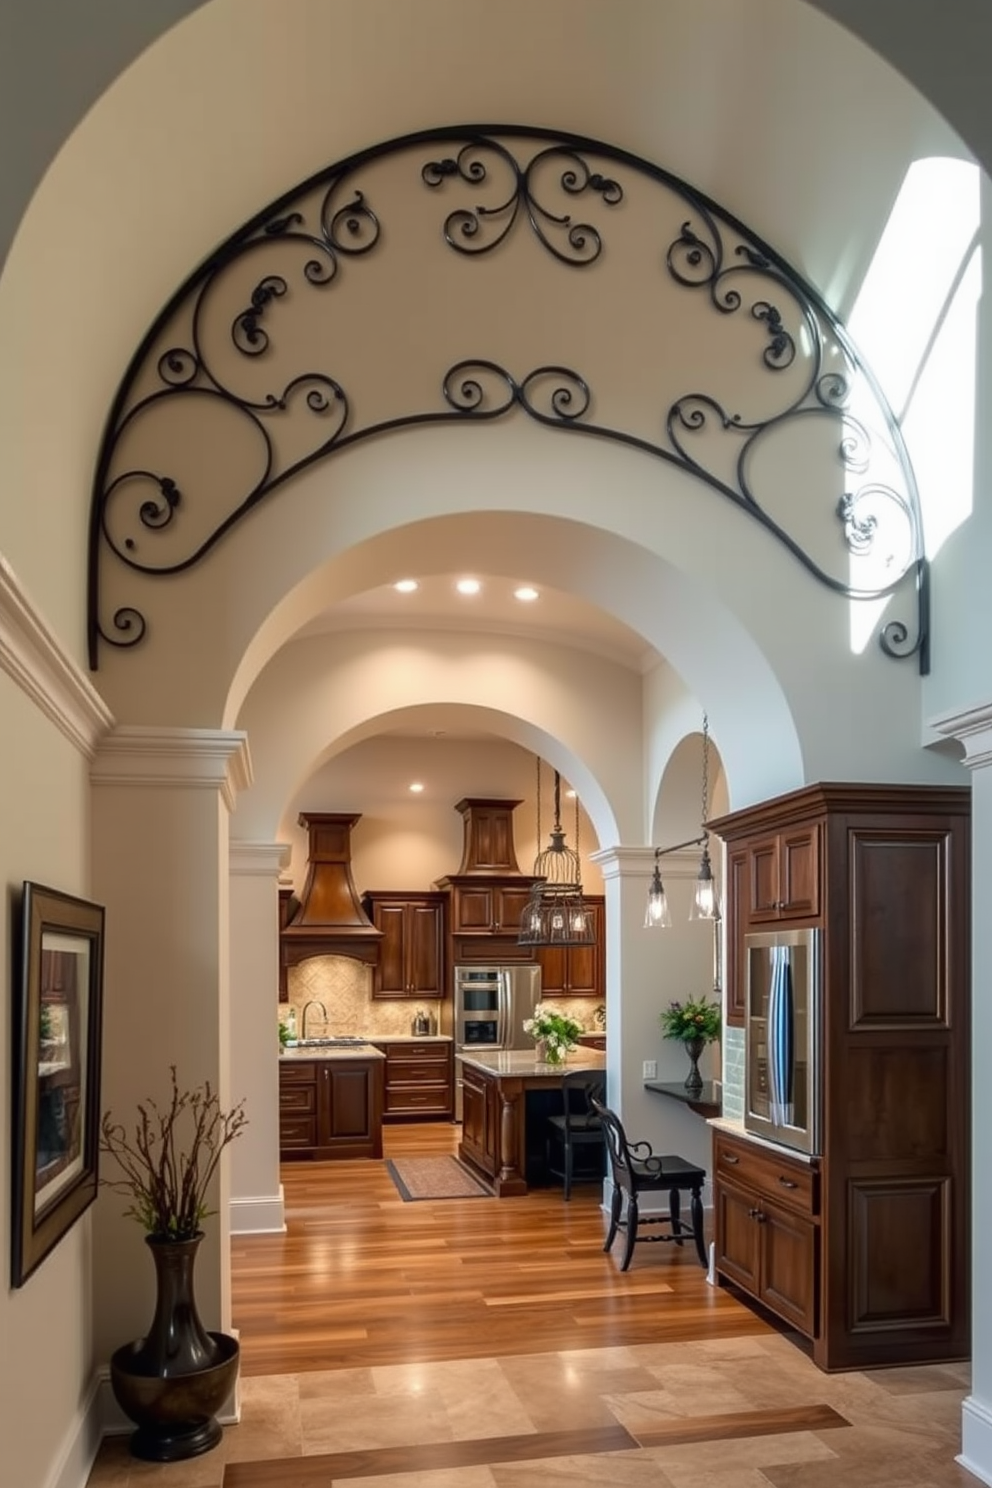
left=89, top=1335, right=977, bottom=1488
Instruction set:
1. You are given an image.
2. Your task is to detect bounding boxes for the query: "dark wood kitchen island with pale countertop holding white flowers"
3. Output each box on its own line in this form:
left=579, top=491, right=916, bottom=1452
left=457, top=1048, right=607, bottom=1198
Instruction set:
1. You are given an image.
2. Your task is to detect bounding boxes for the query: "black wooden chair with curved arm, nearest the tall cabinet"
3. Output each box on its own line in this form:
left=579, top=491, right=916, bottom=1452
left=592, top=1098, right=706, bottom=1271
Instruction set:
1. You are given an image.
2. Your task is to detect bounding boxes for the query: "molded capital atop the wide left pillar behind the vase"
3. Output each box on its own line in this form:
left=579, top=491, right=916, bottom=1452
left=89, top=725, right=251, bottom=811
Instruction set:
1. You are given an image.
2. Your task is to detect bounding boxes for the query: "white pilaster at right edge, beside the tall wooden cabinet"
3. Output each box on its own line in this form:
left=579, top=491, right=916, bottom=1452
left=931, top=702, right=992, bottom=1484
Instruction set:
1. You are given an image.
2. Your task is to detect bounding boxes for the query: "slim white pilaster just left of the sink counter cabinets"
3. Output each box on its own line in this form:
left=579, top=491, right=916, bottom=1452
left=231, top=841, right=292, bottom=1235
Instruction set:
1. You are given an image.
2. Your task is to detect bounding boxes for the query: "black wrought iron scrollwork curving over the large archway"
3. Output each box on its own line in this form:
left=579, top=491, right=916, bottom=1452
left=88, top=125, right=930, bottom=674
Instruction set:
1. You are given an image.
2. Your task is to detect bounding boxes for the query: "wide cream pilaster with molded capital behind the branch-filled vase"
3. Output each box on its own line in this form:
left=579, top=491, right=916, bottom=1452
left=91, top=726, right=251, bottom=1359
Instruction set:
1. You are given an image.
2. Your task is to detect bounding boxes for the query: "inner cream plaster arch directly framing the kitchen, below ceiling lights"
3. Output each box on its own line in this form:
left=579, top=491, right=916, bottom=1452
left=238, top=631, right=642, bottom=844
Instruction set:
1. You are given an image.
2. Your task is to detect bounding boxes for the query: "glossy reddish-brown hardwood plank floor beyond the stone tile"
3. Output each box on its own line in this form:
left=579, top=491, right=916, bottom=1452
left=232, top=1122, right=772, bottom=1375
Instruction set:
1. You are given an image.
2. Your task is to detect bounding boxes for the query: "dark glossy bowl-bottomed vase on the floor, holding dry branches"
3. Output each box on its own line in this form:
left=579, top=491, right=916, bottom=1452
left=110, top=1235, right=239, bottom=1463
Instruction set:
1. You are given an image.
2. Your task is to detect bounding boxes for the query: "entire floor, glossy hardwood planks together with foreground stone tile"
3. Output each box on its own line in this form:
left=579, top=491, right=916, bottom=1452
left=89, top=1123, right=974, bottom=1488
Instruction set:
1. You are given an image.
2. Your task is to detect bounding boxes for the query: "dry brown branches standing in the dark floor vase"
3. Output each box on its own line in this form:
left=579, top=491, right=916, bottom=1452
left=100, top=1065, right=247, bottom=1240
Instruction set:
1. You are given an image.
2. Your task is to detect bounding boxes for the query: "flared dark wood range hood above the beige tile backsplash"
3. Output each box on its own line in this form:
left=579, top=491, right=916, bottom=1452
left=280, top=811, right=382, bottom=967
